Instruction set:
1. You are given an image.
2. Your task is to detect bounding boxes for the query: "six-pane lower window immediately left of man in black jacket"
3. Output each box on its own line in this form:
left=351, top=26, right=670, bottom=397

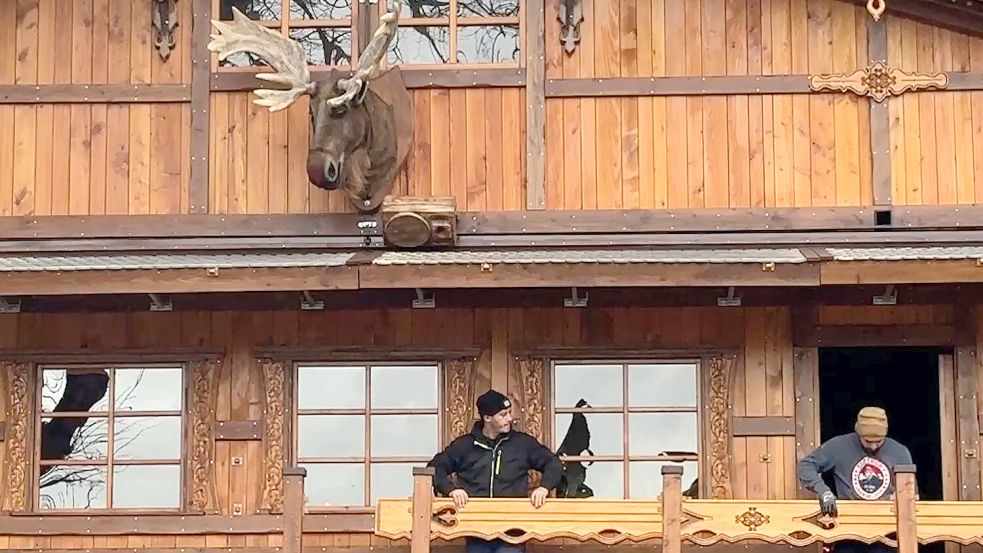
left=294, top=363, right=441, bottom=508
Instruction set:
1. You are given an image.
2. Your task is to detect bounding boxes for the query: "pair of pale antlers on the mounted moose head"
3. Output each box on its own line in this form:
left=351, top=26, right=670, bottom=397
left=208, top=0, right=403, bottom=111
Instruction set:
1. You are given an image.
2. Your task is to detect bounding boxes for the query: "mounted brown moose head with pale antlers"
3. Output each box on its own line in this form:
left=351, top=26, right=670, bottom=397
left=208, top=0, right=413, bottom=213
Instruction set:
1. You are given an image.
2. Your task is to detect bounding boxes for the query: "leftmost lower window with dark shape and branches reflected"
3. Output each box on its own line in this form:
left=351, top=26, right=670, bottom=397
left=35, top=365, right=184, bottom=510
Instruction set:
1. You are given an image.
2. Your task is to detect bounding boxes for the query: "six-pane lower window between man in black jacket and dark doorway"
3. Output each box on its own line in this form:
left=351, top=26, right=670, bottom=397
left=553, top=361, right=700, bottom=499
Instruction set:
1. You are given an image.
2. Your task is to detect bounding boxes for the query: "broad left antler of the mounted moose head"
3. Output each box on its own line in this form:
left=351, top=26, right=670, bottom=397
left=208, top=8, right=314, bottom=111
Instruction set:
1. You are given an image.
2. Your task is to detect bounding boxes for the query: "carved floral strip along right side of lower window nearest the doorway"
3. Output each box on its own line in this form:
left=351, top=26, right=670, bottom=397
left=706, top=357, right=734, bottom=499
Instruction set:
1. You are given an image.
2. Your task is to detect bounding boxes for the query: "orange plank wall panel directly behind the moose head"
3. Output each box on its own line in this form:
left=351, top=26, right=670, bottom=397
left=210, top=88, right=526, bottom=213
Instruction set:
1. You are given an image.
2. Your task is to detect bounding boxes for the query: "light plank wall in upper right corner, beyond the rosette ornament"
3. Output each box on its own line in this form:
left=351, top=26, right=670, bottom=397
left=887, top=18, right=983, bottom=205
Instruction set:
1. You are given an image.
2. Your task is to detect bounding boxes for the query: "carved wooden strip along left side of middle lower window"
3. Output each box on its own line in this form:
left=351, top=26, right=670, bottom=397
left=262, top=361, right=284, bottom=513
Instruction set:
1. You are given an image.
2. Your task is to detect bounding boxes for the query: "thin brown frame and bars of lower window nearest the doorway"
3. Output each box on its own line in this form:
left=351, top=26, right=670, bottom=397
left=547, top=355, right=707, bottom=500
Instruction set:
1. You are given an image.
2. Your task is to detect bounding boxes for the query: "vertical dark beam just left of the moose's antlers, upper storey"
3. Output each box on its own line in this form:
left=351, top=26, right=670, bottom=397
left=188, top=0, right=212, bottom=213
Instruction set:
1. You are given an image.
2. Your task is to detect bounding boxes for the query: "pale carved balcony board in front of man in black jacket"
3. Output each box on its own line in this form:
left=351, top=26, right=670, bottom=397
left=375, top=498, right=662, bottom=545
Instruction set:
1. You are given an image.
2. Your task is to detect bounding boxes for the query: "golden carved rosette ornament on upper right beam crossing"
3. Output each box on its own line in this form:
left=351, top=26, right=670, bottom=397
left=809, top=61, right=949, bottom=102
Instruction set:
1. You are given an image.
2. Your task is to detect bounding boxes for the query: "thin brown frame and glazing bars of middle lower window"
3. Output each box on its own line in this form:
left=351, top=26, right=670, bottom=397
left=287, top=356, right=447, bottom=513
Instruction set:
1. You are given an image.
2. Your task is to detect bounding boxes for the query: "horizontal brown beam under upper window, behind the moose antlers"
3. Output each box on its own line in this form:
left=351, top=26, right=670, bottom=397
left=209, top=66, right=526, bottom=92
